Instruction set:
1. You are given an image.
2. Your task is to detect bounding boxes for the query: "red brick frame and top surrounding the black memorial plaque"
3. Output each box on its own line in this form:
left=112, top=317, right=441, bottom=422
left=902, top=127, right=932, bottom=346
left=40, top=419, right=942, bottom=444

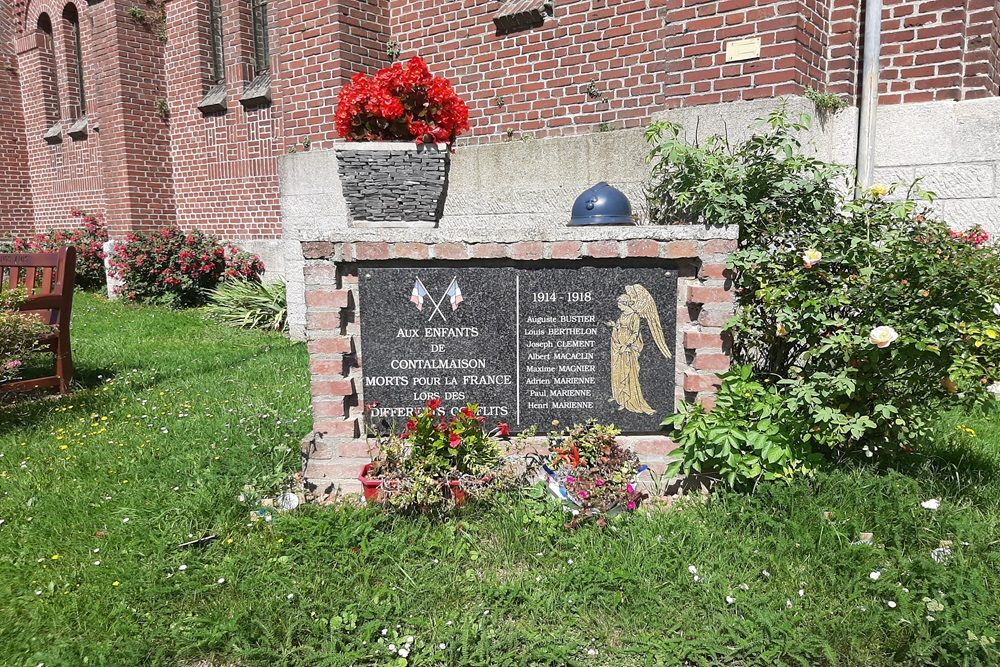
left=302, top=226, right=736, bottom=492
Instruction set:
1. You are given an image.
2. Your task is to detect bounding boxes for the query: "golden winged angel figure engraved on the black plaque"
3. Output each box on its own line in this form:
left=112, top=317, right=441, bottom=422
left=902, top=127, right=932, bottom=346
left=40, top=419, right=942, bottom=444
left=609, top=285, right=671, bottom=415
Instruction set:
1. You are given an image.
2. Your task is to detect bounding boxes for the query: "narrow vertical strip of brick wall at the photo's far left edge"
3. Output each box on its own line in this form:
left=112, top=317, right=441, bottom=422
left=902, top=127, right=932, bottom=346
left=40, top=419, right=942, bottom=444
left=0, top=3, right=34, bottom=238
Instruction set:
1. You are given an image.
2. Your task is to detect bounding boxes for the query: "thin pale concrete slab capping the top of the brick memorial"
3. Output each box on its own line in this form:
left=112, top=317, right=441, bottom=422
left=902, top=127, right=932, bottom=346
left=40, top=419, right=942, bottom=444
left=296, top=225, right=739, bottom=243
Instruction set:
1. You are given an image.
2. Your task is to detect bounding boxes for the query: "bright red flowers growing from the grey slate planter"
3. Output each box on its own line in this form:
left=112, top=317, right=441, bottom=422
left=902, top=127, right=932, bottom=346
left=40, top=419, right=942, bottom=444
left=335, top=57, right=469, bottom=144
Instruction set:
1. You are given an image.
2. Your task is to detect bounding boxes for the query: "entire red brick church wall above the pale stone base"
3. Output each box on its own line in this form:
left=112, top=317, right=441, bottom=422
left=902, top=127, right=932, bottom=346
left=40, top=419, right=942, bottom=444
left=0, top=0, right=1000, bottom=238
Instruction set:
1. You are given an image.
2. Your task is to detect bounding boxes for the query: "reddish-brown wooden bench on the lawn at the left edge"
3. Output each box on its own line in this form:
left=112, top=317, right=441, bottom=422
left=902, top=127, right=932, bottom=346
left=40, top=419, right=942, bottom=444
left=0, top=247, right=76, bottom=394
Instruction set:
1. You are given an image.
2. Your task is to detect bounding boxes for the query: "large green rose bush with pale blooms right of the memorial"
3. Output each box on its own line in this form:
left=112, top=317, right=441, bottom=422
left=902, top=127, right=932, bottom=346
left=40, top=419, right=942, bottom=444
left=647, top=103, right=1000, bottom=478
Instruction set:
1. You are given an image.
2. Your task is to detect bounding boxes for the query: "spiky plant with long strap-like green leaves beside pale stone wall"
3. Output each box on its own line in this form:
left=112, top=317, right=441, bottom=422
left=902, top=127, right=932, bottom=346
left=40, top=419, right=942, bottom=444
left=206, top=279, right=288, bottom=331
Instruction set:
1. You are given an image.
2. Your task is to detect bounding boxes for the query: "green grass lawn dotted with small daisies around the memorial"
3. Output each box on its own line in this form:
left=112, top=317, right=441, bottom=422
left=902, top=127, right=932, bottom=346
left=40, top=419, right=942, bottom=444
left=0, top=295, right=1000, bottom=667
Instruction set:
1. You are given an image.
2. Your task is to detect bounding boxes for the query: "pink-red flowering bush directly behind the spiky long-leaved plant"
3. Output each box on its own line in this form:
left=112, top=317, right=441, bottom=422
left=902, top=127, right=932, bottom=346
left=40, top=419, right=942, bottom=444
left=109, top=227, right=264, bottom=307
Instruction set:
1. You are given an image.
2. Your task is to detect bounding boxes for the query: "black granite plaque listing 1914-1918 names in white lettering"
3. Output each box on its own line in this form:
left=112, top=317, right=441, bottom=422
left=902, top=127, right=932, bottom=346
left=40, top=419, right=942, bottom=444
left=359, top=265, right=677, bottom=433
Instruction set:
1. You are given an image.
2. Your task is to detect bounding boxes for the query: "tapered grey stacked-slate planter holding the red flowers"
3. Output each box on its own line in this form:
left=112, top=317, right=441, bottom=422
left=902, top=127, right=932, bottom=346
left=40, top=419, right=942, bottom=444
left=335, top=141, right=449, bottom=227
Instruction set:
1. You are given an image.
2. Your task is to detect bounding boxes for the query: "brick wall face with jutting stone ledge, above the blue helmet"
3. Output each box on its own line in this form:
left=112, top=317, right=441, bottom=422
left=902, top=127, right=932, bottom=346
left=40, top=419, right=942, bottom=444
left=390, top=0, right=676, bottom=143
